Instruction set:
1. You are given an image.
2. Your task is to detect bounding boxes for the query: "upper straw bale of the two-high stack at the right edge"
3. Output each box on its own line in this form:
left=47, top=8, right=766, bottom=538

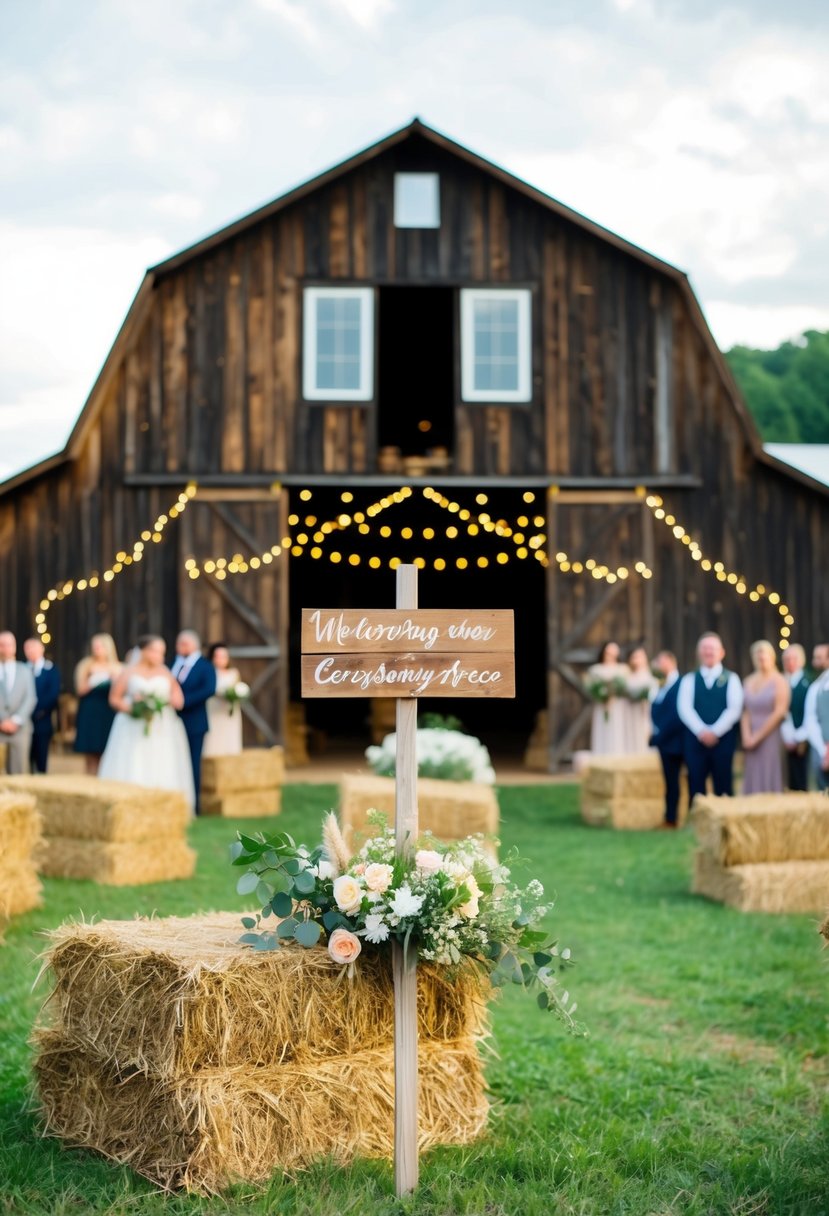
left=692, top=793, right=829, bottom=870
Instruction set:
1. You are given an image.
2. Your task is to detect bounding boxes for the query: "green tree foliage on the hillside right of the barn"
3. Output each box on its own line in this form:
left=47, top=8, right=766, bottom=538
left=726, top=330, right=829, bottom=444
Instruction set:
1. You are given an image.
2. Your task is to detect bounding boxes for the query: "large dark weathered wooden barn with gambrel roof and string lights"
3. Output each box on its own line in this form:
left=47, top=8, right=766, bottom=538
left=0, top=120, right=829, bottom=766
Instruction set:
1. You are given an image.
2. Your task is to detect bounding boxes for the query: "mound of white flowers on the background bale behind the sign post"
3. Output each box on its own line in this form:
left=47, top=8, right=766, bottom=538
left=366, top=714, right=495, bottom=786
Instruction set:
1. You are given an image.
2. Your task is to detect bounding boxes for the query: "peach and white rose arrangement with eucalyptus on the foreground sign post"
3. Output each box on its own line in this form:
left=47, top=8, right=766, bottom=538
left=231, top=811, right=583, bottom=1034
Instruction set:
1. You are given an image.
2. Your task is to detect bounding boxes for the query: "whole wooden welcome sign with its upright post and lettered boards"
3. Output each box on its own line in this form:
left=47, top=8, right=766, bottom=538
left=301, top=565, right=515, bottom=1197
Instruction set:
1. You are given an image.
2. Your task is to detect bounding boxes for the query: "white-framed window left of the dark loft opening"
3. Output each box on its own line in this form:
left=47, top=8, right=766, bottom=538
left=303, top=287, right=374, bottom=401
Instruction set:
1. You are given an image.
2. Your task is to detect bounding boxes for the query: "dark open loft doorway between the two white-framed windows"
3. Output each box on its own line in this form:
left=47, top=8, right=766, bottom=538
left=377, top=287, right=455, bottom=467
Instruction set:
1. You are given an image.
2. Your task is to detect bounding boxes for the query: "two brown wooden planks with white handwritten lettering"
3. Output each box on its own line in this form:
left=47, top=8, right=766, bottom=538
left=301, top=608, right=515, bottom=697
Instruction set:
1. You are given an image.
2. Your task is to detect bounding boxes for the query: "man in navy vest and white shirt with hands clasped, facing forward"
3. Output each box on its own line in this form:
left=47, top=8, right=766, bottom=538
left=677, top=634, right=743, bottom=800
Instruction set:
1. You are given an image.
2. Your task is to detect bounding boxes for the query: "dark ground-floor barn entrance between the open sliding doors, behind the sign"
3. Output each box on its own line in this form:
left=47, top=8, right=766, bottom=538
left=288, top=486, right=547, bottom=756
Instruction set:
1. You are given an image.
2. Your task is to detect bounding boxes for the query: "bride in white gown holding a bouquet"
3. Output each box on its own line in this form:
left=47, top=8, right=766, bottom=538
left=98, top=636, right=196, bottom=807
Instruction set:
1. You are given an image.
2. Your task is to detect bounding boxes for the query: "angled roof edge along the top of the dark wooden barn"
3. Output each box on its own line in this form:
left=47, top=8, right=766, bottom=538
left=0, top=118, right=827, bottom=495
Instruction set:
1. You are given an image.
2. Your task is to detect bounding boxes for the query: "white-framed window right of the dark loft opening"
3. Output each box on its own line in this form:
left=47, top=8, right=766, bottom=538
left=461, top=287, right=532, bottom=401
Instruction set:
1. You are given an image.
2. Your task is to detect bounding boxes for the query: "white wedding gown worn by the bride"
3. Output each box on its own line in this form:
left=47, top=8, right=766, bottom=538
left=98, top=675, right=196, bottom=807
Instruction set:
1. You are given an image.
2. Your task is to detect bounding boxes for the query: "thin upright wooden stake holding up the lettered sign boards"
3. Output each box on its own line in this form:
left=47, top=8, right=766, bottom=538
left=393, top=565, right=418, bottom=1197
